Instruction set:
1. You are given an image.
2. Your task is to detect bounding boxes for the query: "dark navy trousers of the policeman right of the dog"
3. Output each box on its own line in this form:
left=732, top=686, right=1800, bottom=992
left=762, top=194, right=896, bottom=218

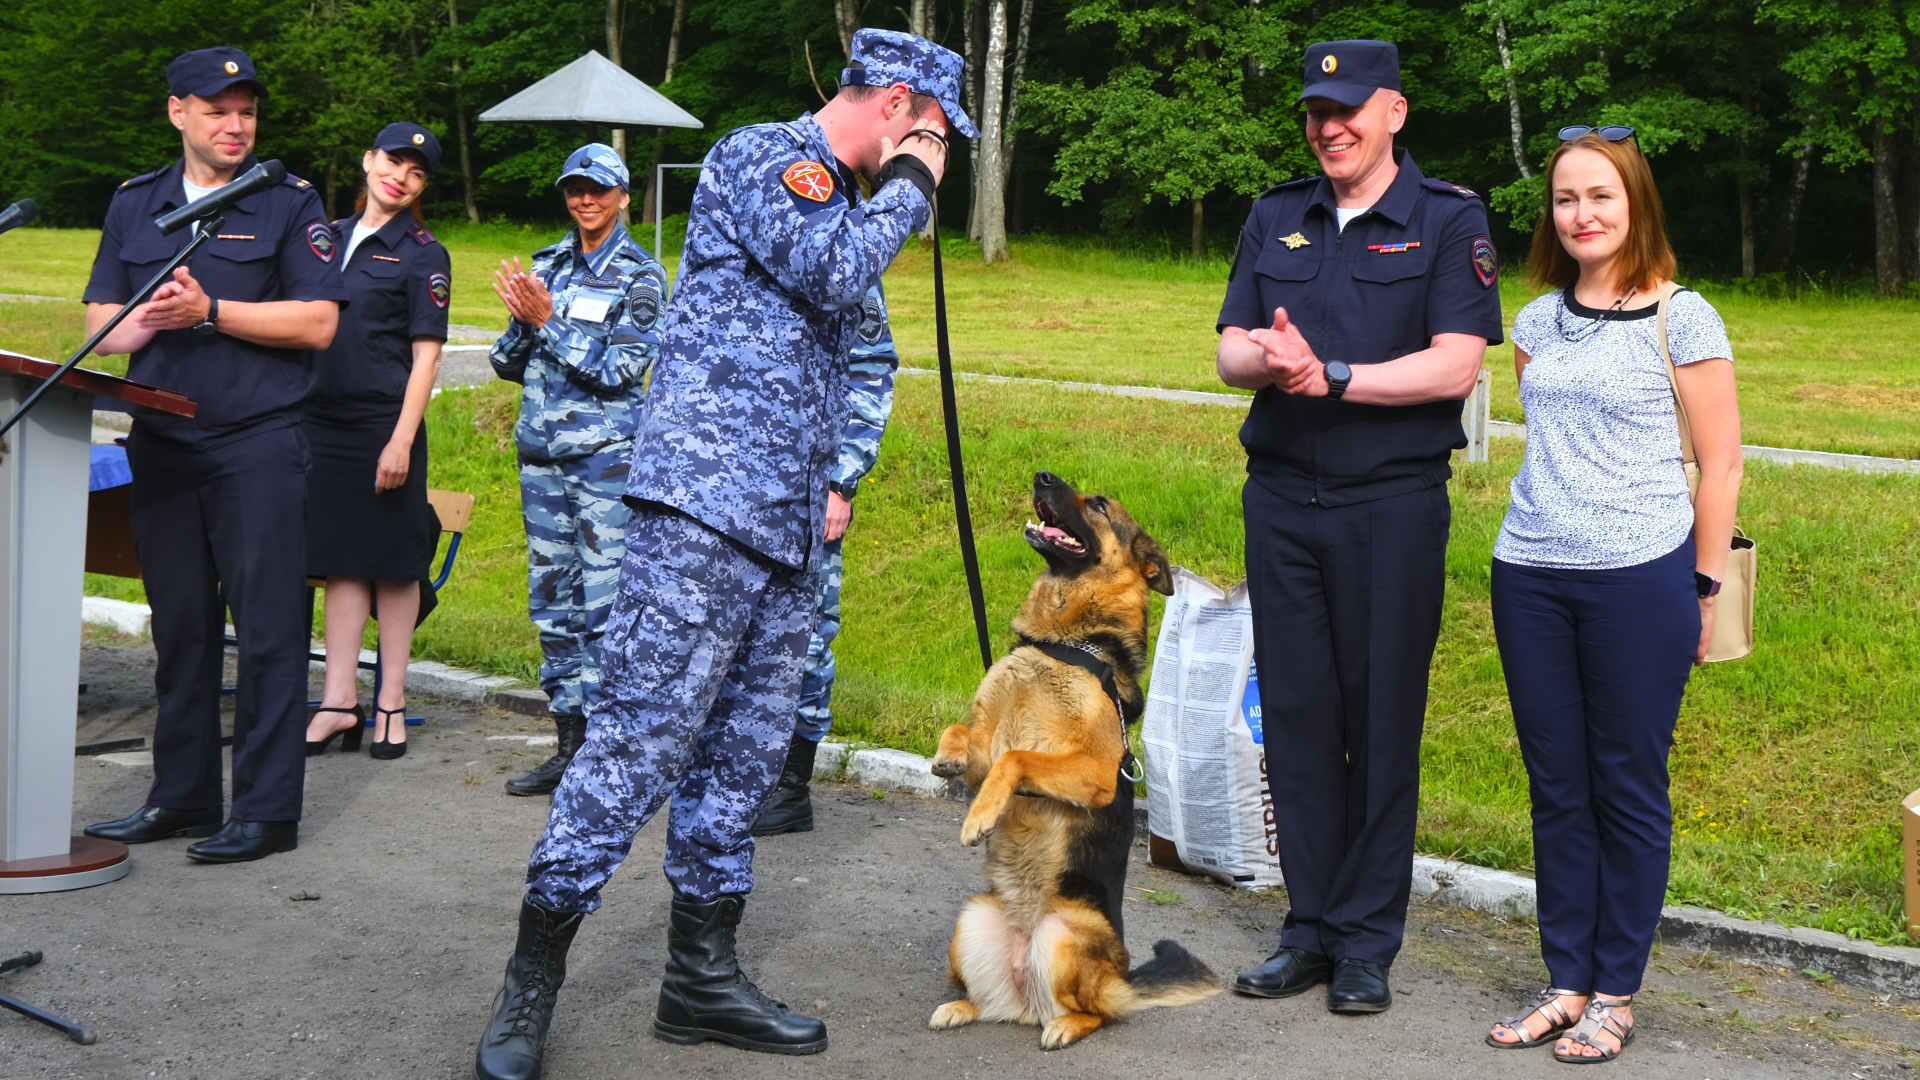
left=1240, top=479, right=1453, bottom=965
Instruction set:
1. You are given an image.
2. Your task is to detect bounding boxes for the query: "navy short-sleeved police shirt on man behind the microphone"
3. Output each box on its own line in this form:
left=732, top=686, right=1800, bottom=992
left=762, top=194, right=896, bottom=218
left=83, top=156, right=348, bottom=448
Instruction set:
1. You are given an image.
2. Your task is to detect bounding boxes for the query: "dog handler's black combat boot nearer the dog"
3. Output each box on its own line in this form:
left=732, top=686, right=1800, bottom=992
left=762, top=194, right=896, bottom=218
left=653, top=894, right=828, bottom=1053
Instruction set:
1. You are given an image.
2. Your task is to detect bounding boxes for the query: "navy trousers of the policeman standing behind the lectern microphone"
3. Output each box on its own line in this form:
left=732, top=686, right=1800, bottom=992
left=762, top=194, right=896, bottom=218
left=127, top=423, right=313, bottom=821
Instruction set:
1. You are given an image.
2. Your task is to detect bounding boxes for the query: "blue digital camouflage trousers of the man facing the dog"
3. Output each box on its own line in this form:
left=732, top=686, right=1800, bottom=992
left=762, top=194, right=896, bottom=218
left=526, top=503, right=818, bottom=911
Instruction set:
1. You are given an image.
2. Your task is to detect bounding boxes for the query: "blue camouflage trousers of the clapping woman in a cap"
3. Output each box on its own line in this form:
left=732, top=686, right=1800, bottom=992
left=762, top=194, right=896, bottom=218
left=520, top=442, right=634, bottom=717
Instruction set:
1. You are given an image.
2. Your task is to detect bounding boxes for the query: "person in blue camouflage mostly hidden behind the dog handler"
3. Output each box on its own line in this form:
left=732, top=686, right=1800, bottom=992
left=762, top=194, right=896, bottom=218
left=753, top=282, right=900, bottom=836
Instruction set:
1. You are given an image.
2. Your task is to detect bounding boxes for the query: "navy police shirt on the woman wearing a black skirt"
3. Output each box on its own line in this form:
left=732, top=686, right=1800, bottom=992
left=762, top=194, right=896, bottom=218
left=307, top=213, right=453, bottom=421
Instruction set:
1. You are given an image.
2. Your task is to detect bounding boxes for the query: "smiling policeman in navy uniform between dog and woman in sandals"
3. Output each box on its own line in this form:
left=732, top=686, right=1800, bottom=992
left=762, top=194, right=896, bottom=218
left=1217, top=40, right=1501, bottom=1013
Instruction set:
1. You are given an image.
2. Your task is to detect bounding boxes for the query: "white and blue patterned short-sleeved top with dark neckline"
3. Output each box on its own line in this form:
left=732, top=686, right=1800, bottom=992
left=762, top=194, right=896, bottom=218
left=1494, top=288, right=1734, bottom=571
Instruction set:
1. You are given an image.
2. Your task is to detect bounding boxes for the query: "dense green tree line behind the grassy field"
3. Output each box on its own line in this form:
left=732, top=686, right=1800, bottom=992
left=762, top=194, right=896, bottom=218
left=0, top=0, right=1920, bottom=294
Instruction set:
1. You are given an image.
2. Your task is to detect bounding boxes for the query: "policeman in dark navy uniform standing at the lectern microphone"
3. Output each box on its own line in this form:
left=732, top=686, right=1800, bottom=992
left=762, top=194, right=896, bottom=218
left=84, top=48, right=348, bottom=863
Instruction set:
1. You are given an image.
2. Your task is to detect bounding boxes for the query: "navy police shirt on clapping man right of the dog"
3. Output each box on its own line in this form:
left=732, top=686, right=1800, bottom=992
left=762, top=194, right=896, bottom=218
left=1219, top=150, right=1501, bottom=505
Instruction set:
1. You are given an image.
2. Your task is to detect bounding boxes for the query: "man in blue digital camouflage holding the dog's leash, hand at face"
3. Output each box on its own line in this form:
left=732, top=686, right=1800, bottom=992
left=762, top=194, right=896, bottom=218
left=476, top=31, right=975, bottom=1080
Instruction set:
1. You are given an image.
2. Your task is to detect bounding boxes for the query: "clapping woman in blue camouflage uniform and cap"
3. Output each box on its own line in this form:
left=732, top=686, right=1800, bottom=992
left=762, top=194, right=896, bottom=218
left=490, top=142, right=666, bottom=796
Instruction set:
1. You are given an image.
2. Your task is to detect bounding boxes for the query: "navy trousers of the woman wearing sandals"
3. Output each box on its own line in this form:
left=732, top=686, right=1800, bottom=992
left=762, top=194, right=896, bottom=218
left=1494, top=538, right=1699, bottom=995
